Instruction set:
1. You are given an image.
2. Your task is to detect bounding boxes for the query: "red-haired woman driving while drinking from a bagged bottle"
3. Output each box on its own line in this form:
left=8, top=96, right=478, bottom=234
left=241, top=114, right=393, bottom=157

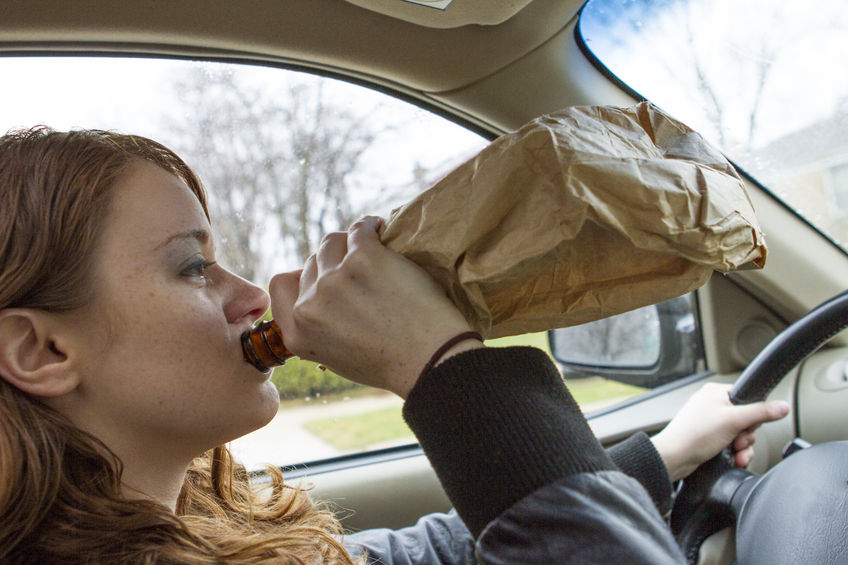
left=0, top=125, right=785, bottom=564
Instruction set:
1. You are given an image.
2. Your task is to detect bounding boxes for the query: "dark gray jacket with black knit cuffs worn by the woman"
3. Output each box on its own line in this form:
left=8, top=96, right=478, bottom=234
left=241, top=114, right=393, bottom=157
left=344, top=348, right=685, bottom=565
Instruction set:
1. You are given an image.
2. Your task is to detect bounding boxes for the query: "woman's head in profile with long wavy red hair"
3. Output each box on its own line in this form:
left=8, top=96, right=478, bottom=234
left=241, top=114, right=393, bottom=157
left=0, top=125, right=350, bottom=563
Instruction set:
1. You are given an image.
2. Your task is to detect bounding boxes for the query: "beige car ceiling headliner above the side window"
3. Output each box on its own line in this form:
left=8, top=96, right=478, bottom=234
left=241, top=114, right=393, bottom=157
left=0, top=0, right=582, bottom=93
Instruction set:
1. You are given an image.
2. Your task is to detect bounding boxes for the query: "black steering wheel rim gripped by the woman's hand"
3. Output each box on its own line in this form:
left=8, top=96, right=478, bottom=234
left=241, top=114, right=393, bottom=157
left=671, top=290, right=848, bottom=565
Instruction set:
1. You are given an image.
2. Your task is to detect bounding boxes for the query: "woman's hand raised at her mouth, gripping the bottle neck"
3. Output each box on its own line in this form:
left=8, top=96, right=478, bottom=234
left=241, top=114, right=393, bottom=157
left=270, top=217, right=480, bottom=398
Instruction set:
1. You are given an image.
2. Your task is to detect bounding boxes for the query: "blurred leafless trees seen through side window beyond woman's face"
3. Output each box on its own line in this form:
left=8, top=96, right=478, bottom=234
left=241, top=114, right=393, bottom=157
left=169, top=67, right=408, bottom=280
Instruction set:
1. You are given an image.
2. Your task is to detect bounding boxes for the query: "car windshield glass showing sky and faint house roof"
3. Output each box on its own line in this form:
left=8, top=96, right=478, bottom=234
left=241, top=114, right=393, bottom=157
left=579, top=0, right=848, bottom=249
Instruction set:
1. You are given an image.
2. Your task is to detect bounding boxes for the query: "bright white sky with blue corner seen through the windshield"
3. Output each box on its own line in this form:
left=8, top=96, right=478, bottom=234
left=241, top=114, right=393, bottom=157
left=581, top=0, right=848, bottom=152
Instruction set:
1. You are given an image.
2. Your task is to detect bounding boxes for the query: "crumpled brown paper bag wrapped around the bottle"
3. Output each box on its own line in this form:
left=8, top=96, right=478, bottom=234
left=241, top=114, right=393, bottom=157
left=380, top=102, right=766, bottom=338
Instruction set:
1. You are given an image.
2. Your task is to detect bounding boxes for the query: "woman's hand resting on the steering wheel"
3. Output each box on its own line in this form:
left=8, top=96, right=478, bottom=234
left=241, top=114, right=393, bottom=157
left=651, top=383, right=789, bottom=481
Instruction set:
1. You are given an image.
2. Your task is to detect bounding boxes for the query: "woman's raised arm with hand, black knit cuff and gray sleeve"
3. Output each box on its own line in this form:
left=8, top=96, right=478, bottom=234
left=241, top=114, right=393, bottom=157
left=270, top=220, right=682, bottom=563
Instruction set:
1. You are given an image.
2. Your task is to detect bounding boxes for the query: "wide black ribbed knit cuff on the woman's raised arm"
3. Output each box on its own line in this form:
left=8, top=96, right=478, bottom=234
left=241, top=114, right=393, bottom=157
left=404, top=347, right=616, bottom=537
